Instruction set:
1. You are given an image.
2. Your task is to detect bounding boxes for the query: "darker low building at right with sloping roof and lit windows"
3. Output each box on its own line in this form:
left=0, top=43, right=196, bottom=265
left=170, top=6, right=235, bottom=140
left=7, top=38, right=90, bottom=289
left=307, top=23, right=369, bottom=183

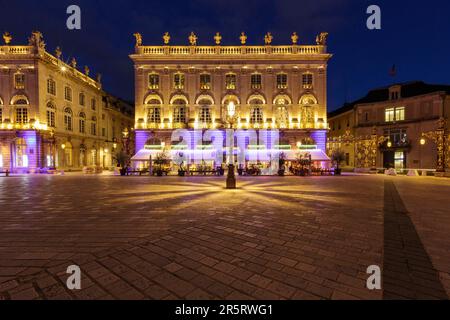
left=328, top=81, right=450, bottom=172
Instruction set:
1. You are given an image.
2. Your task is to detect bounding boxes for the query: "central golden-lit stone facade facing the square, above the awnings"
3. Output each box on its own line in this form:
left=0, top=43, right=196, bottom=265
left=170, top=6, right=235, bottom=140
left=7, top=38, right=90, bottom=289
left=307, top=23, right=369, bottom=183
left=130, top=33, right=332, bottom=169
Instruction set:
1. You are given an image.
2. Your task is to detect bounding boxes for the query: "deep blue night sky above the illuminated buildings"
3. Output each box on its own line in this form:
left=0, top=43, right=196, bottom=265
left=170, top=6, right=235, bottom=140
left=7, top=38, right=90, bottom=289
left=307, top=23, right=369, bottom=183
left=0, top=0, right=450, bottom=110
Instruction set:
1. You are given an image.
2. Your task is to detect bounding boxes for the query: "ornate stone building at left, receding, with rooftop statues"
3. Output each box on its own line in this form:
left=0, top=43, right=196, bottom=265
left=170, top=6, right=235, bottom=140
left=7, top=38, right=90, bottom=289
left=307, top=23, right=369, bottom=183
left=0, top=32, right=133, bottom=173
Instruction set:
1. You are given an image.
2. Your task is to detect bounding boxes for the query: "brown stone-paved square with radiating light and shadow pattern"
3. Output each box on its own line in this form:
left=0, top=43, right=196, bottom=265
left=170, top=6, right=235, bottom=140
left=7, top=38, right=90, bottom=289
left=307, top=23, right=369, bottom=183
left=0, top=175, right=450, bottom=300
